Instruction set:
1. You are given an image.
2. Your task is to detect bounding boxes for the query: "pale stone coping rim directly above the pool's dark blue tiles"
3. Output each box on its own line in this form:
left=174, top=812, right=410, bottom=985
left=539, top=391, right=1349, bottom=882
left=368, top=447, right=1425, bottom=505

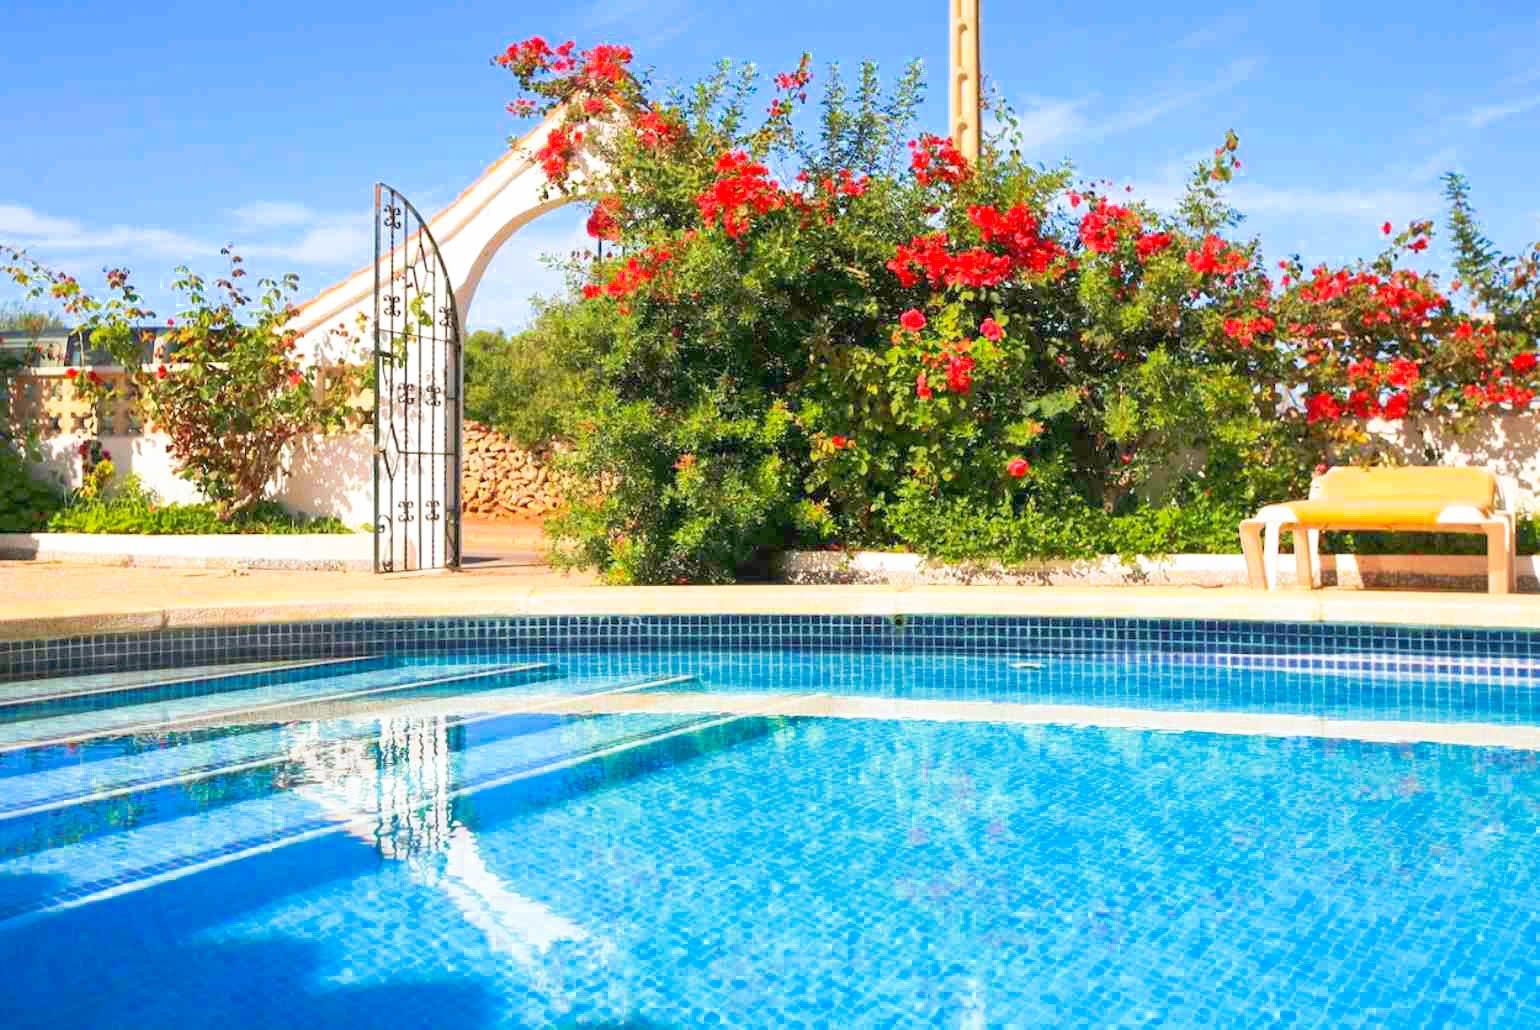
left=0, top=576, right=1540, bottom=640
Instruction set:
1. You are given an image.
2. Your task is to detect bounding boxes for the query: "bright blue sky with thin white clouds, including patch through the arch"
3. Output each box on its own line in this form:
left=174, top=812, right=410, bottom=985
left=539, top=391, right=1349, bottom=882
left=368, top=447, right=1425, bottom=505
left=0, top=0, right=1540, bottom=328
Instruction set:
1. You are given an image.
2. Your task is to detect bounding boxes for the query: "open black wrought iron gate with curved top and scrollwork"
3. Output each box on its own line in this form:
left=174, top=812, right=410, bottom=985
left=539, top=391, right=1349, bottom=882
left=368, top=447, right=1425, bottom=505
left=374, top=183, right=464, bottom=573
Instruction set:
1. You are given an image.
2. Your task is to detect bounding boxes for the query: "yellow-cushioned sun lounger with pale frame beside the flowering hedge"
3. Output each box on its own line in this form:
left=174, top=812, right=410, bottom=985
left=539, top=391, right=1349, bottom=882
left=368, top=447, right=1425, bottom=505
left=1241, top=467, right=1518, bottom=594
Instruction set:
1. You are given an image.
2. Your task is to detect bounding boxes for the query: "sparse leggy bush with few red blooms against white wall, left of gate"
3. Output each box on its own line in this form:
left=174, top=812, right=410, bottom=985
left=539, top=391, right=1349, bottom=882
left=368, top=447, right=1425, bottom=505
left=0, top=248, right=359, bottom=522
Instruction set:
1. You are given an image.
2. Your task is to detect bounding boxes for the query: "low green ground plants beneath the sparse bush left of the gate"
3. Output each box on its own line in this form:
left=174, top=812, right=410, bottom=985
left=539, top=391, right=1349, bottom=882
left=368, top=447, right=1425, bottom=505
left=46, top=476, right=350, bottom=536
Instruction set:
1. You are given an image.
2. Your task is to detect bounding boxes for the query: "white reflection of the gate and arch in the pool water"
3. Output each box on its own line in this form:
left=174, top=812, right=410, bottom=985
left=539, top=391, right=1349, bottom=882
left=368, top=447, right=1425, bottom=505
left=288, top=716, right=597, bottom=979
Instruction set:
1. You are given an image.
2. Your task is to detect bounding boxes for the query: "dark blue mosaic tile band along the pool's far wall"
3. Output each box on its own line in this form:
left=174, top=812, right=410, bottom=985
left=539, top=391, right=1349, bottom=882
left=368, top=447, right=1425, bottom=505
left=0, top=614, right=1540, bottom=682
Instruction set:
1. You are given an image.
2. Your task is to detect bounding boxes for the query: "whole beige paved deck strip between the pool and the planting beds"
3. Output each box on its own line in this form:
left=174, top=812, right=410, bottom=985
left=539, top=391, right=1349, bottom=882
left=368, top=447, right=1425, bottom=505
left=0, top=562, right=1540, bottom=640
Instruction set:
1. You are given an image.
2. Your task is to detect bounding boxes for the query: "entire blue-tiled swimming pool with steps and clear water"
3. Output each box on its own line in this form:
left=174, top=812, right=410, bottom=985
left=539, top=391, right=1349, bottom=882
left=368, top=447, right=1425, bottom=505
left=0, top=616, right=1540, bottom=1028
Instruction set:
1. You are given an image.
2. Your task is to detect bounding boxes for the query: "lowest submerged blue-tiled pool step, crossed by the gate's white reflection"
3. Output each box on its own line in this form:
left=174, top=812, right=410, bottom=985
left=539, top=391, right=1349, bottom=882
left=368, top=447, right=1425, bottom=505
left=0, top=696, right=801, bottom=927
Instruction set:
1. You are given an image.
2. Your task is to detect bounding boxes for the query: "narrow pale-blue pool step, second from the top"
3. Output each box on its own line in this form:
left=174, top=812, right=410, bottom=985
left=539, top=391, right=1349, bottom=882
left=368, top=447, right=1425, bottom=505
left=0, top=662, right=551, bottom=753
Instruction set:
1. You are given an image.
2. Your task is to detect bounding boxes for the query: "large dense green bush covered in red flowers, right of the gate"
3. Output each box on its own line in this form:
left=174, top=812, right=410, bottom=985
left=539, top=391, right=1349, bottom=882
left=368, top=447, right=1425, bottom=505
left=497, top=40, right=1537, bottom=582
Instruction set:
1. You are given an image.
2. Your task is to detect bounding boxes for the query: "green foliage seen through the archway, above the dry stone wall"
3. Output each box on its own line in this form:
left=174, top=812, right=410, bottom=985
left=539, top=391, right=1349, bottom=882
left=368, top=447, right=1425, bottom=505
left=465, top=305, right=591, bottom=448
